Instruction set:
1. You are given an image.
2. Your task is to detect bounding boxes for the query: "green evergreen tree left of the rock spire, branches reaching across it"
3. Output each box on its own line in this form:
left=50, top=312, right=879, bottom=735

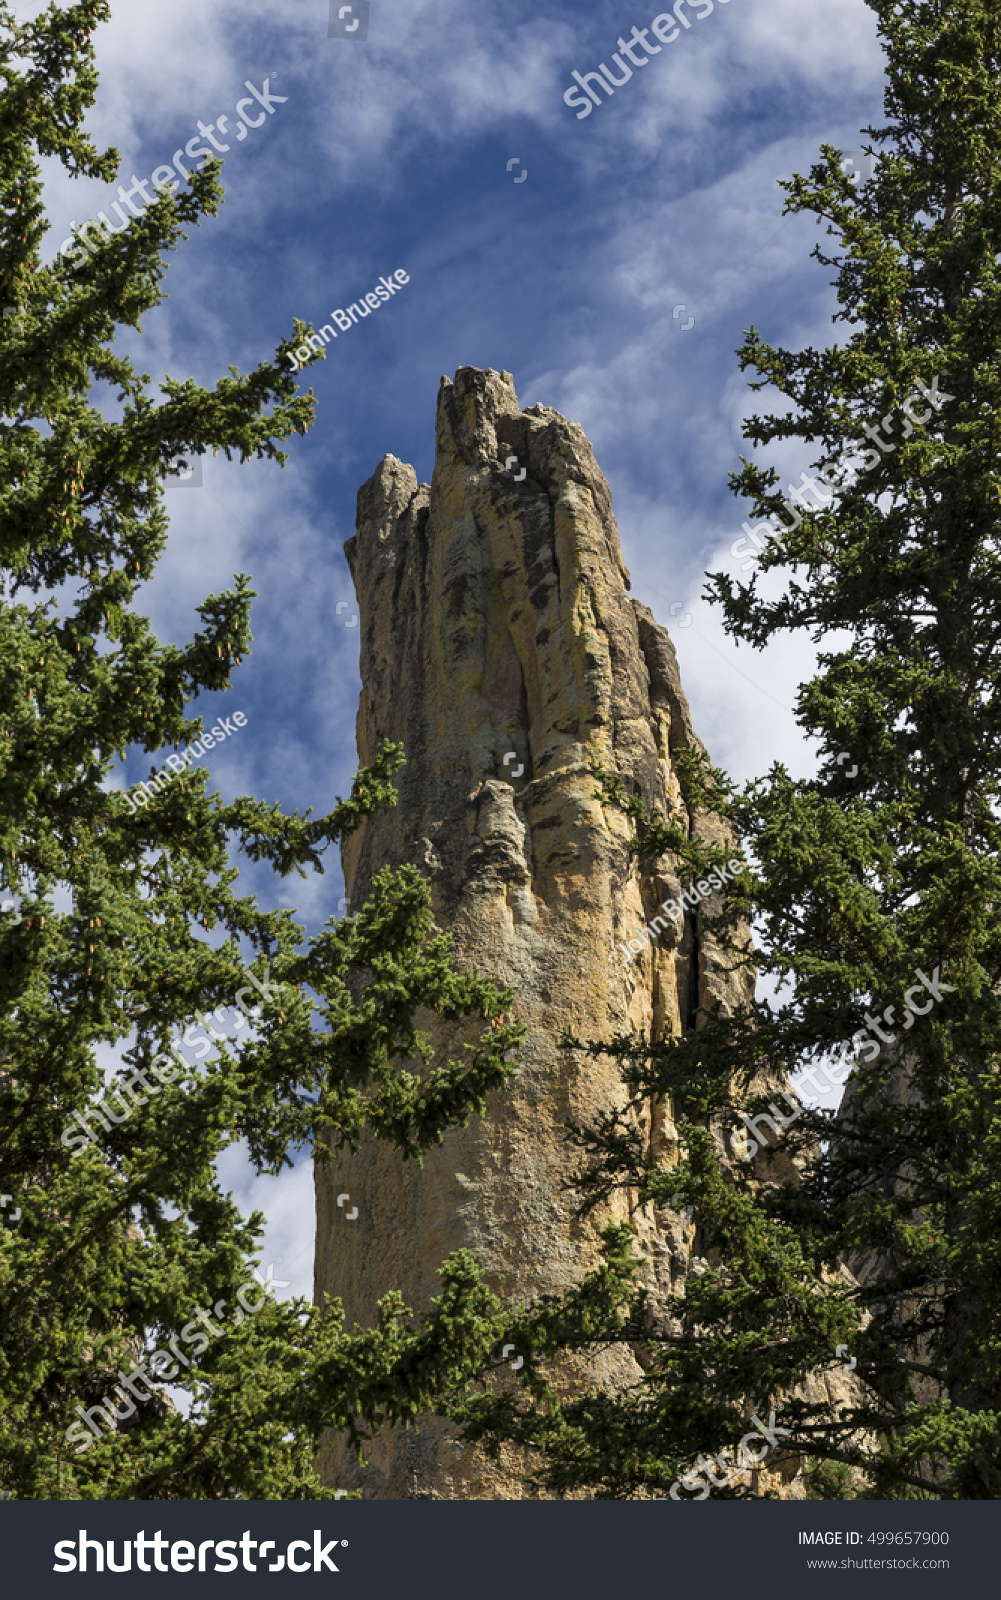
left=0, top=0, right=521, bottom=1499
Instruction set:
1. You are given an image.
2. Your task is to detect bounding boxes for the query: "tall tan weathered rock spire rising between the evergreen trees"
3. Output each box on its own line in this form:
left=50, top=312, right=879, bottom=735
left=315, top=368, right=745, bottom=1498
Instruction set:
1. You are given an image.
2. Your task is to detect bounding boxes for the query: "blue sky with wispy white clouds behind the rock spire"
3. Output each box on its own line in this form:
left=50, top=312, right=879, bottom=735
left=29, top=0, right=883, bottom=1293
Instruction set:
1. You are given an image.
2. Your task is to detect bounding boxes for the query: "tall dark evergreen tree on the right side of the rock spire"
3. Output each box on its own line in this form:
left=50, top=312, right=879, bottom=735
left=453, top=0, right=1001, bottom=1499
